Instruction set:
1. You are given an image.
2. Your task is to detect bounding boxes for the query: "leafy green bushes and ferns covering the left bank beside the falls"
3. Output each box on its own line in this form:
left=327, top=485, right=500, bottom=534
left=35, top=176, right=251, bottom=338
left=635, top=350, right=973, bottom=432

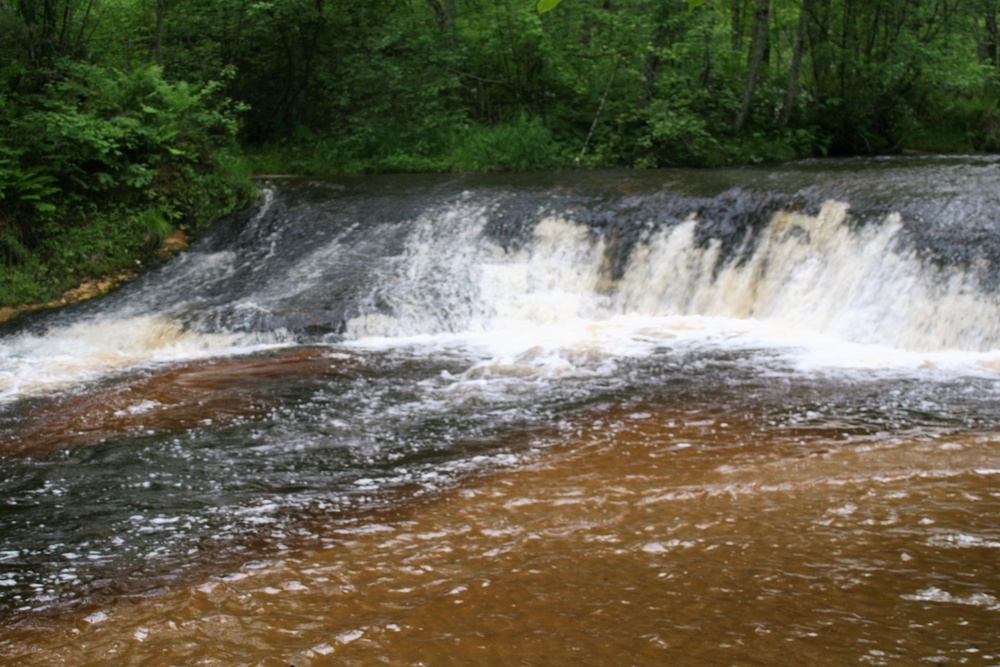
left=0, top=61, right=253, bottom=304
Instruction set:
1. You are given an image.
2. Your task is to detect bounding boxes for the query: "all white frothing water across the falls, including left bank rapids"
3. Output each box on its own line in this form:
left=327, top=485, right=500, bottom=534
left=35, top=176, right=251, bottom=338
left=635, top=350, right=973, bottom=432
left=0, top=193, right=1000, bottom=400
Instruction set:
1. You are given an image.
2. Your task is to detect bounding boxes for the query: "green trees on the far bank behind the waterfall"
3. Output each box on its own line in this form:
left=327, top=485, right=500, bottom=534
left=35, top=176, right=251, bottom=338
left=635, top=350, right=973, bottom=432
left=166, top=0, right=996, bottom=174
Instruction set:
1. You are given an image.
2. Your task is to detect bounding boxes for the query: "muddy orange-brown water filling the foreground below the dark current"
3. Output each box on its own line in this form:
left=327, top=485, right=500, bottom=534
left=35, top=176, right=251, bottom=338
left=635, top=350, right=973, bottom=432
left=0, top=404, right=1000, bottom=667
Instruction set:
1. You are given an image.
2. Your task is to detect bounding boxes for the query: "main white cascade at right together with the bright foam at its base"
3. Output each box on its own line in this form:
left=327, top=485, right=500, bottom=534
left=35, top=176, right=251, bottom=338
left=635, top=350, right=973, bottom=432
left=348, top=201, right=1000, bottom=374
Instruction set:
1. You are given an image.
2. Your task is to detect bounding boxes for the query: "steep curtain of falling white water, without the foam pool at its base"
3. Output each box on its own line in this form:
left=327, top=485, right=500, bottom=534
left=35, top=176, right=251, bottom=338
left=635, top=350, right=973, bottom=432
left=347, top=200, right=1000, bottom=352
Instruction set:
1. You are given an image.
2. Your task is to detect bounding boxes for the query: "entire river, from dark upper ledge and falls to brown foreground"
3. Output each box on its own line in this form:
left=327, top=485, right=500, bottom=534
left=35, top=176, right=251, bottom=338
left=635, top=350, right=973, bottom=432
left=0, top=157, right=1000, bottom=667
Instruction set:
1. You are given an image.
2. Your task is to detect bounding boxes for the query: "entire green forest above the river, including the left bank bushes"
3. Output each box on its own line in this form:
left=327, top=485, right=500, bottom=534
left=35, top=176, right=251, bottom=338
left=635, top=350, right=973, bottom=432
left=0, top=0, right=1000, bottom=305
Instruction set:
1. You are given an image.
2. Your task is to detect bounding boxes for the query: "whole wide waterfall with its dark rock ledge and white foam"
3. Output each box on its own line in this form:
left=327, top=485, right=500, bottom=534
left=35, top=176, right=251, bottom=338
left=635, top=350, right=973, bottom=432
left=0, top=160, right=1000, bottom=400
